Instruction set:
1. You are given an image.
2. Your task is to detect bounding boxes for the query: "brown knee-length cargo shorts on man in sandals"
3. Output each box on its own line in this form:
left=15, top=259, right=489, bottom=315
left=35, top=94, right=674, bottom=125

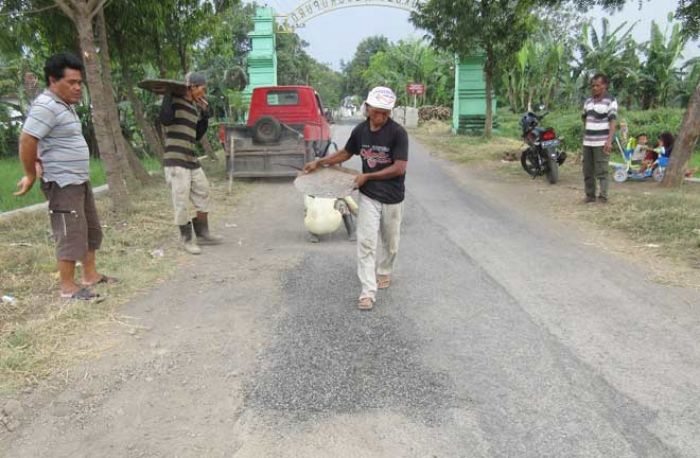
left=41, top=181, right=102, bottom=261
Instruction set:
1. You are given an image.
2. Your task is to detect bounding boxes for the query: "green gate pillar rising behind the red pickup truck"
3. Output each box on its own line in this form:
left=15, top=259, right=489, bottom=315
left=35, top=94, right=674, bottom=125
left=243, top=8, right=277, bottom=112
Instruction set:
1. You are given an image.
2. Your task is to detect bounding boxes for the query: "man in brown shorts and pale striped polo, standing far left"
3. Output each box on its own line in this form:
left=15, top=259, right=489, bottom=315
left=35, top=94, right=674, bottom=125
left=15, top=53, right=117, bottom=300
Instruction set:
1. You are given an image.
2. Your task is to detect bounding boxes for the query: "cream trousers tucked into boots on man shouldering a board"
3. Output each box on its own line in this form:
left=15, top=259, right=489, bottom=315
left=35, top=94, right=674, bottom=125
left=163, top=166, right=209, bottom=226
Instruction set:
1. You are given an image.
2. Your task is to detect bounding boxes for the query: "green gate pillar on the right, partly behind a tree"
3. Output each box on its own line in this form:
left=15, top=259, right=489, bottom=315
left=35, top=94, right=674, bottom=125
left=452, top=54, right=496, bottom=134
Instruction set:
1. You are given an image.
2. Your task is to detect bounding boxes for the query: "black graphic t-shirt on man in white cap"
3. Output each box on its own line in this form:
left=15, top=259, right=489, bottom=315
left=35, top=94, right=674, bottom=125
left=345, top=118, right=408, bottom=204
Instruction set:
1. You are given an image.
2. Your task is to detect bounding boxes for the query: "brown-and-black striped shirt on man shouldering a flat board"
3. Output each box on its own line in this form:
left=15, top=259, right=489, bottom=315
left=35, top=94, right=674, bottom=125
left=160, top=95, right=209, bottom=169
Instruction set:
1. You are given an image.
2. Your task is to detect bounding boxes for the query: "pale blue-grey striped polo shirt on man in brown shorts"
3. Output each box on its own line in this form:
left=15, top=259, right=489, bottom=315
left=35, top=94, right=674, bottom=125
left=22, top=89, right=90, bottom=187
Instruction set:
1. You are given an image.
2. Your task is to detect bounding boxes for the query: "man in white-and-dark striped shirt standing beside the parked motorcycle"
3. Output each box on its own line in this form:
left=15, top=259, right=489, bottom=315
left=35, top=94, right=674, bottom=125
left=582, top=73, right=617, bottom=203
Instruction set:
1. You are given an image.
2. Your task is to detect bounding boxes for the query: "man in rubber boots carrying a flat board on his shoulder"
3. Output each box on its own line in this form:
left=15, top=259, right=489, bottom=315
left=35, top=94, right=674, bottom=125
left=160, top=73, right=221, bottom=254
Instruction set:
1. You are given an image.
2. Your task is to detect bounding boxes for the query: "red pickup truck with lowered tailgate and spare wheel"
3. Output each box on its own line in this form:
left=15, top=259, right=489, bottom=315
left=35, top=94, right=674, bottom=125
left=219, top=86, right=331, bottom=177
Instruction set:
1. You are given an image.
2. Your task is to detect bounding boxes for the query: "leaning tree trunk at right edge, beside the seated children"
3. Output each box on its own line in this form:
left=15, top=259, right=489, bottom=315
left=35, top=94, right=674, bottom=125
left=661, top=83, right=700, bottom=188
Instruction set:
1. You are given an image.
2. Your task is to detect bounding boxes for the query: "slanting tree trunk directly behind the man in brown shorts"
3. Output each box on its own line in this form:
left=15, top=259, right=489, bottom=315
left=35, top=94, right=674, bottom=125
left=74, top=12, right=131, bottom=215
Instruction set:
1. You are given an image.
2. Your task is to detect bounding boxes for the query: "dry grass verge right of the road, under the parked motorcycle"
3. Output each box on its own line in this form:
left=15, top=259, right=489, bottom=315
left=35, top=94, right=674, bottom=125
left=411, top=122, right=700, bottom=280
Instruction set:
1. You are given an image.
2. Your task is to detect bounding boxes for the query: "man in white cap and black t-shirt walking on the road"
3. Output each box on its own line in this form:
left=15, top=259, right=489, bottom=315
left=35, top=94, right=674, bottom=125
left=304, top=86, right=408, bottom=310
